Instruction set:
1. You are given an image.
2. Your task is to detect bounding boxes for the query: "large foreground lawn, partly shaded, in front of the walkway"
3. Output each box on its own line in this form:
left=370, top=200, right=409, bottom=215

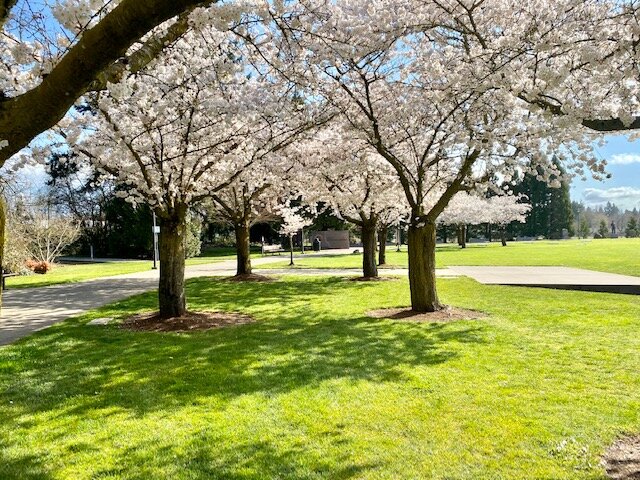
left=0, top=277, right=640, bottom=480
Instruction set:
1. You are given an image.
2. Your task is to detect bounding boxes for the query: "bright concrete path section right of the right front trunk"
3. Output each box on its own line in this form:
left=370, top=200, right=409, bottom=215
left=449, top=266, right=640, bottom=295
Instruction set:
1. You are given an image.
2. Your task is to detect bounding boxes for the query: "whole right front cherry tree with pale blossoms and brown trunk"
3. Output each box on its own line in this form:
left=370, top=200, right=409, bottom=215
left=255, top=0, right=635, bottom=311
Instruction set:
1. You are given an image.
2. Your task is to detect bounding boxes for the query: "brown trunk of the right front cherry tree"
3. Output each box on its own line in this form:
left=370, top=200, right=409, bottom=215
left=409, top=223, right=442, bottom=312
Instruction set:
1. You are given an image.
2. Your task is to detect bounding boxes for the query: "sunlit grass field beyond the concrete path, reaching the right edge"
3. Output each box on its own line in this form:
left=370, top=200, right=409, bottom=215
left=260, top=238, right=640, bottom=276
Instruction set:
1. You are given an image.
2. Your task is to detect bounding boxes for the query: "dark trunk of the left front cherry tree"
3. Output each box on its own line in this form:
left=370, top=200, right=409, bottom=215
left=158, top=205, right=187, bottom=318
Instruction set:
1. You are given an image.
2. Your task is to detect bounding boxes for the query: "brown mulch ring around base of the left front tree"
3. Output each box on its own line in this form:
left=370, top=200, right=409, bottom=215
left=120, top=312, right=255, bottom=332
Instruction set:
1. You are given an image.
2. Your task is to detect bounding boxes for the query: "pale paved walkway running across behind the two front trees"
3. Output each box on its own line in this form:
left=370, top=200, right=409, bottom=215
left=0, top=258, right=640, bottom=345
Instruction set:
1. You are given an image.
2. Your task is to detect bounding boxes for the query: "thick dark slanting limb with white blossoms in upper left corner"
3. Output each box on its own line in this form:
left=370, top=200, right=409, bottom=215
left=0, top=0, right=251, bottom=166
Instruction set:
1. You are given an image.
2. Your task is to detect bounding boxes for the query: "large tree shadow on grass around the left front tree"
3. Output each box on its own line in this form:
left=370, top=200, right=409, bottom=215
left=4, top=279, right=483, bottom=414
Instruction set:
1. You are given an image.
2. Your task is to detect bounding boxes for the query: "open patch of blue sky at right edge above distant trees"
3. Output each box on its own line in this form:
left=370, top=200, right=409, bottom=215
left=571, top=135, right=640, bottom=210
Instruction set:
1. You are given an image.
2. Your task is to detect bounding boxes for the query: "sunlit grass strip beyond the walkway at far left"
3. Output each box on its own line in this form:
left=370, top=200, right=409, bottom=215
left=6, top=248, right=242, bottom=288
